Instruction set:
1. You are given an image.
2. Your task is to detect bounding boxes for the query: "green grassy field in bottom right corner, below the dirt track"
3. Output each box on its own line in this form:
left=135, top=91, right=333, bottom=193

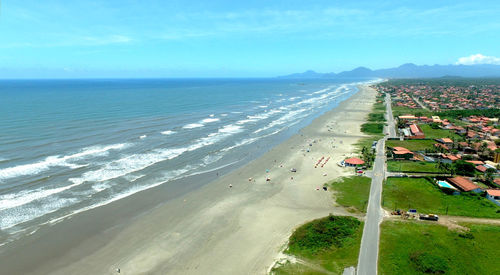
left=379, top=221, right=500, bottom=275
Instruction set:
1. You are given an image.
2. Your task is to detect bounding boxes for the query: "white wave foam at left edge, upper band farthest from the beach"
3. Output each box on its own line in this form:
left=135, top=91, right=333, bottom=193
left=0, top=143, right=130, bottom=181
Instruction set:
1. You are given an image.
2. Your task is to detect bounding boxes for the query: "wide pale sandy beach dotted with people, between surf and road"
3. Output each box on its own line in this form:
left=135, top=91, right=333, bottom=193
left=0, top=86, right=375, bottom=274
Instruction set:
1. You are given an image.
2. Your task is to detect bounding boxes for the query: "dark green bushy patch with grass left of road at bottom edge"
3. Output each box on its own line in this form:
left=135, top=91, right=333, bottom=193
left=271, top=215, right=363, bottom=274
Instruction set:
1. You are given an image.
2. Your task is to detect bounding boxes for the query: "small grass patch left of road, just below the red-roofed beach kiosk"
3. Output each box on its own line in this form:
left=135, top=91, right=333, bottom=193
left=328, top=176, right=371, bottom=213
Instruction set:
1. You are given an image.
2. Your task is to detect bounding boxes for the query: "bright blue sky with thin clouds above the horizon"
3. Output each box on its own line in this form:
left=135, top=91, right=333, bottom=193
left=0, top=0, right=500, bottom=78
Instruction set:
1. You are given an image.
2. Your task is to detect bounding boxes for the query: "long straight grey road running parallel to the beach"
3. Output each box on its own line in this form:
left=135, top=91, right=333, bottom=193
left=357, top=94, right=396, bottom=275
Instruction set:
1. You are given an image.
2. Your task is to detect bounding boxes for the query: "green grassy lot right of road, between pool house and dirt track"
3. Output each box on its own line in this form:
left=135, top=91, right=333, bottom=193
left=382, top=178, right=500, bottom=218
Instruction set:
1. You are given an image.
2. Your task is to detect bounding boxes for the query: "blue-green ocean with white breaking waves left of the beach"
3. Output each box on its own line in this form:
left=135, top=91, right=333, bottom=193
left=0, top=79, right=372, bottom=246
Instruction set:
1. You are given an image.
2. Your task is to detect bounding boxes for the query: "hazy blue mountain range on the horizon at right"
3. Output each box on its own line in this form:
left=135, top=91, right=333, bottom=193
left=280, top=63, right=500, bottom=78
